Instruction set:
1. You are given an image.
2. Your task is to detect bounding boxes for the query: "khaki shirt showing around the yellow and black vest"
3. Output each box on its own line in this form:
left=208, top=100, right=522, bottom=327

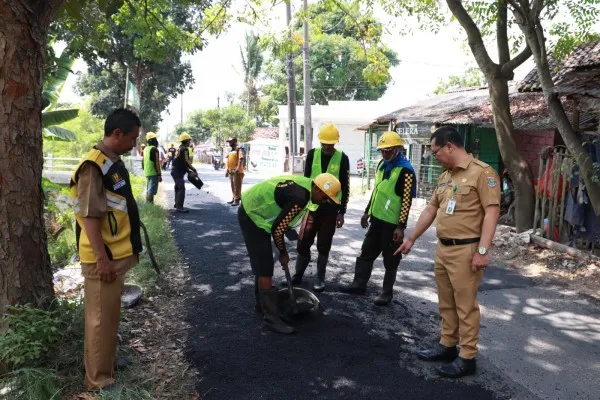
left=77, top=141, right=138, bottom=279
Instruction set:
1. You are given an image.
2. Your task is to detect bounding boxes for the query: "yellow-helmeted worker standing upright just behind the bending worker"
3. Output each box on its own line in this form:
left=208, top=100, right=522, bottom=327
left=293, top=124, right=350, bottom=292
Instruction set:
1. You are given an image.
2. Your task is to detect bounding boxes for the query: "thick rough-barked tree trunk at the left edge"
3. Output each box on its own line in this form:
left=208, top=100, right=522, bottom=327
left=0, top=1, right=60, bottom=313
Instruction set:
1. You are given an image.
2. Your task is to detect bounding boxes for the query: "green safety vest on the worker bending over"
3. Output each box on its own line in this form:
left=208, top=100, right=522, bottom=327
left=242, top=175, right=312, bottom=233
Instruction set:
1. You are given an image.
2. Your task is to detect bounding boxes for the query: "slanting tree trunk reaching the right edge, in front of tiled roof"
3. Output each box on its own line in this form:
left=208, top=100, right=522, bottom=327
left=515, top=14, right=600, bottom=216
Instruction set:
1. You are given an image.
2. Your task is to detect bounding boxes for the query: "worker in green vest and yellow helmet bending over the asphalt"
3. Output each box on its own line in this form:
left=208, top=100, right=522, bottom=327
left=238, top=173, right=340, bottom=334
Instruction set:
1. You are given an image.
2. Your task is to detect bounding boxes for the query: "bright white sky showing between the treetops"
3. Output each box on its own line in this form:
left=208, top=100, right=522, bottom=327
left=61, top=1, right=533, bottom=134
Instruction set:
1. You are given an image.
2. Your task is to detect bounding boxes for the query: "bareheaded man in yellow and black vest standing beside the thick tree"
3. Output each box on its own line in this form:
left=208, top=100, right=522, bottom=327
left=71, top=109, right=142, bottom=390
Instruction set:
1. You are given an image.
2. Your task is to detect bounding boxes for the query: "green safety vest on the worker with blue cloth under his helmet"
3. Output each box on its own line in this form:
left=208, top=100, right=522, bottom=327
left=369, top=163, right=402, bottom=225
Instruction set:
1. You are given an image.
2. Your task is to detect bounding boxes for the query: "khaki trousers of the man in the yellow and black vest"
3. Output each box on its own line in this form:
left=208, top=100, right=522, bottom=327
left=81, top=255, right=137, bottom=390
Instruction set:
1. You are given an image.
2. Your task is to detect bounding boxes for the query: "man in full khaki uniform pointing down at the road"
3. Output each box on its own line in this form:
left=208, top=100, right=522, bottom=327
left=396, top=126, right=500, bottom=378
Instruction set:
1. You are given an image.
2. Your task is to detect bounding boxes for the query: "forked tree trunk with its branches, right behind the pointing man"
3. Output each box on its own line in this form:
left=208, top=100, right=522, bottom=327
left=446, top=0, right=535, bottom=232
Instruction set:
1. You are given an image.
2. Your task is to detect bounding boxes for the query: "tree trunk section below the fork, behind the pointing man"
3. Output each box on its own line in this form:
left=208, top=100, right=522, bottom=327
left=488, top=78, right=534, bottom=232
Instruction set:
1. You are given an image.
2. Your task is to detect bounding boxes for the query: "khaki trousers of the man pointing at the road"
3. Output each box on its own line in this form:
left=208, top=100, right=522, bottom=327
left=434, top=242, right=483, bottom=359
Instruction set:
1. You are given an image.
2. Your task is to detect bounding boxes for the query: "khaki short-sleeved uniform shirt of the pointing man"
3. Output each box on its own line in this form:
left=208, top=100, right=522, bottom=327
left=429, top=155, right=500, bottom=239
